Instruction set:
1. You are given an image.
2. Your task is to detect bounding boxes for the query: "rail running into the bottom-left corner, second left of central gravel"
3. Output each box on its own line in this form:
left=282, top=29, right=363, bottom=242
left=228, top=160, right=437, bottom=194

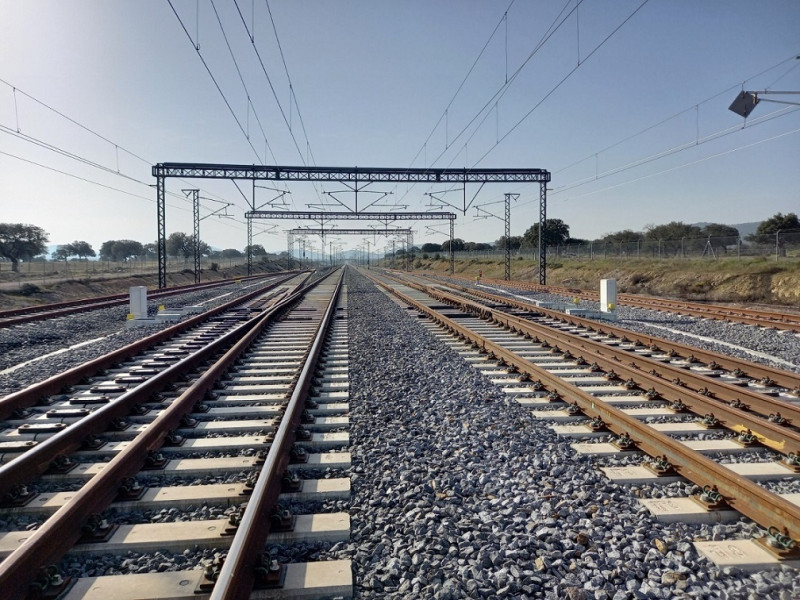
left=0, top=270, right=328, bottom=600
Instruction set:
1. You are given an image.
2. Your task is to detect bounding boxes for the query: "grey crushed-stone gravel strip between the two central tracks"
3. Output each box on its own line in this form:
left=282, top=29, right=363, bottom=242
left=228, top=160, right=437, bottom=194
left=326, top=274, right=800, bottom=600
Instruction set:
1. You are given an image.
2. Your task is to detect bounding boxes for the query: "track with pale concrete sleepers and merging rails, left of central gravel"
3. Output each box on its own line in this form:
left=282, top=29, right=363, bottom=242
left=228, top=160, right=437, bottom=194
left=0, top=272, right=351, bottom=599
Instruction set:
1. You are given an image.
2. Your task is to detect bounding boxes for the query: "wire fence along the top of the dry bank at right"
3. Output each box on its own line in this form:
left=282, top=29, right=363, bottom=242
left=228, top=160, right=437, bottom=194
left=446, top=230, right=800, bottom=261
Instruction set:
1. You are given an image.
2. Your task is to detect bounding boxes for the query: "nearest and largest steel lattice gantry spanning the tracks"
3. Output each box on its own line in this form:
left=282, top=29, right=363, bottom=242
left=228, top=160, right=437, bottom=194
left=152, top=163, right=550, bottom=288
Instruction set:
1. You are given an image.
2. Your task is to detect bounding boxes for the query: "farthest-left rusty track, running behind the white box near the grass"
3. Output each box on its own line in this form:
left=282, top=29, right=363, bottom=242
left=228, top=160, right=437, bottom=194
left=0, top=275, right=296, bottom=329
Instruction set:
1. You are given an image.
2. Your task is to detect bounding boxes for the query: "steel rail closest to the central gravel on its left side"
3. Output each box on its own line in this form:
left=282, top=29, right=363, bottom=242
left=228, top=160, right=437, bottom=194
left=210, top=271, right=343, bottom=600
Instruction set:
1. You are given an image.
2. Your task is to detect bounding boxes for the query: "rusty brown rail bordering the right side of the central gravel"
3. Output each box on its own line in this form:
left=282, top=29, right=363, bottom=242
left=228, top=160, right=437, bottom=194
left=362, top=272, right=800, bottom=541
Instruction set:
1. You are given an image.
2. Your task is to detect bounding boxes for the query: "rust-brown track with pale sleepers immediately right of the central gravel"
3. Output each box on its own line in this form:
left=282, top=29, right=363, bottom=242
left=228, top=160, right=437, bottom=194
left=371, top=274, right=800, bottom=567
